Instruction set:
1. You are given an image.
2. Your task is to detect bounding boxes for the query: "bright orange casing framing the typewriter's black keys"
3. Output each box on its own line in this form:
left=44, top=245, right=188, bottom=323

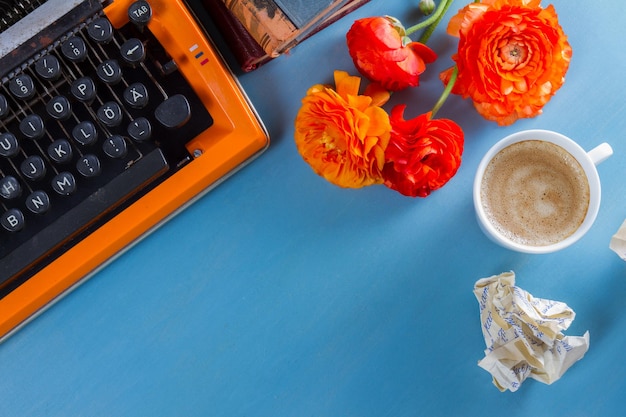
left=0, top=0, right=269, bottom=337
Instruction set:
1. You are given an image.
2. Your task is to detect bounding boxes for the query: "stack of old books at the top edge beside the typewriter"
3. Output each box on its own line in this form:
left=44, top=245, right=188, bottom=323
left=202, top=0, right=369, bottom=71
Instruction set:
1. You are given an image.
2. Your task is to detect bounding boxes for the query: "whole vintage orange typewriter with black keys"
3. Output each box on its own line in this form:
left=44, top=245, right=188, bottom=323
left=0, top=0, right=269, bottom=338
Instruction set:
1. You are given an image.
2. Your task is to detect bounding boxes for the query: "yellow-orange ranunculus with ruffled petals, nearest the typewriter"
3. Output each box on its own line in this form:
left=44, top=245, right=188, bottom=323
left=294, top=71, right=391, bottom=188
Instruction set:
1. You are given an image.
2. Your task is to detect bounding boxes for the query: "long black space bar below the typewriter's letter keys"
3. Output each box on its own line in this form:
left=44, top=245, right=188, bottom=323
left=0, top=149, right=169, bottom=285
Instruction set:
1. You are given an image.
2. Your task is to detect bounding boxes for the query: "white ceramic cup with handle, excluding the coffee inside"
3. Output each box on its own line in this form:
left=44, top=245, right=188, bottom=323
left=473, top=130, right=613, bottom=253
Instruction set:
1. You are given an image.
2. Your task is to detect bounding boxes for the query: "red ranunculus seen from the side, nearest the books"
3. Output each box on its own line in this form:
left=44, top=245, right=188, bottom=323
left=346, top=16, right=437, bottom=91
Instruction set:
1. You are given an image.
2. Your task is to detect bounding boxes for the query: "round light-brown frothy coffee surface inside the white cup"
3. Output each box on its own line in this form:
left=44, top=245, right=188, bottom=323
left=480, top=140, right=589, bottom=246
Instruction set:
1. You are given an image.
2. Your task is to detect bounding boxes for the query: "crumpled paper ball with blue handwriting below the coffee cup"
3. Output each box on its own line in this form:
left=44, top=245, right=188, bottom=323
left=474, top=272, right=589, bottom=392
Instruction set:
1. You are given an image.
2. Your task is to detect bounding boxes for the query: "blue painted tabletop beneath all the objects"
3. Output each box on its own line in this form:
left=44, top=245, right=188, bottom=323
left=0, top=0, right=626, bottom=417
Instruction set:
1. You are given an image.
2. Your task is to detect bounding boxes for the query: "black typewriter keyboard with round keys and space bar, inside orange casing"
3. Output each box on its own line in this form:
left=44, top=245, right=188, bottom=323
left=0, top=2, right=213, bottom=291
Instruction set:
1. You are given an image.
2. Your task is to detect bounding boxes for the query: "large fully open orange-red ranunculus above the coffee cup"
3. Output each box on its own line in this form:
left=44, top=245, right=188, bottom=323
left=440, top=0, right=572, bottom=125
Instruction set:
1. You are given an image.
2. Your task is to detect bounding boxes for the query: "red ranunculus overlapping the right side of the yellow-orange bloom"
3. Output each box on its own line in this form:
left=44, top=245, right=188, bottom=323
left=383, top=105, right=464, bottom=197
